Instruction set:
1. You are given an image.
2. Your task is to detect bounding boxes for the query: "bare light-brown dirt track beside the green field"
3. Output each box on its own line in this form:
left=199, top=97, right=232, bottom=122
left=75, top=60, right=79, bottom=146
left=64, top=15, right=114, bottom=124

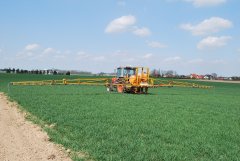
left=0, top=93, right=71, bottom=161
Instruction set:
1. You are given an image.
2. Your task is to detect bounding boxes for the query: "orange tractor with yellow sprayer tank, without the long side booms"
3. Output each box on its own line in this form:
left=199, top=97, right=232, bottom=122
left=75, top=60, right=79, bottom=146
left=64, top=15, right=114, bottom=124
left=106, top=66, right=153, bottom=94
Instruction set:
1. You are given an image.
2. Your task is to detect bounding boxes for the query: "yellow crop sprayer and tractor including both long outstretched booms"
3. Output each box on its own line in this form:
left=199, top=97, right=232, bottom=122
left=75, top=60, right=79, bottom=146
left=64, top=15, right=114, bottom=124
left=10, top=67, right=211, bottom=94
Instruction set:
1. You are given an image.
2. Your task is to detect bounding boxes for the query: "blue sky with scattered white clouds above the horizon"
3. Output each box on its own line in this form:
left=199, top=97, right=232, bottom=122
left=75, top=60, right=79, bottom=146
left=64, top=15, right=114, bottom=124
left=0, top=0, right=240, bottom=76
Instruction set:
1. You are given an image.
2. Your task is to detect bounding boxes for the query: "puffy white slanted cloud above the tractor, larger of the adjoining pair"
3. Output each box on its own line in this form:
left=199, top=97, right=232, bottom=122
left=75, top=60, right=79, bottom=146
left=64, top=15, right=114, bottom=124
left=105, top=15, right=136, bottom=33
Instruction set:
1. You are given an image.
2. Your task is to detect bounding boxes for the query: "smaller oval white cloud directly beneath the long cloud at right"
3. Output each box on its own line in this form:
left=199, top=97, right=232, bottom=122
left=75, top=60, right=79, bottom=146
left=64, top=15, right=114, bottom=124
left=197, top=36, right=231, bottom=49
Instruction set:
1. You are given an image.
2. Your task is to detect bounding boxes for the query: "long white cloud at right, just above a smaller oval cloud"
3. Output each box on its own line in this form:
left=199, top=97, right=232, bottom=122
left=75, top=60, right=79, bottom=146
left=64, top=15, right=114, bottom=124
left=180, top=17, right=232, bottom=35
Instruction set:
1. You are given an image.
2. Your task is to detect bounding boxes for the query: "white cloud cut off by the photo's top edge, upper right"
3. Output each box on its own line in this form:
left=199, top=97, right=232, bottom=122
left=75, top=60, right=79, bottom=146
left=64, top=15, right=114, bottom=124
left=184, top=0, right=227, bottom=7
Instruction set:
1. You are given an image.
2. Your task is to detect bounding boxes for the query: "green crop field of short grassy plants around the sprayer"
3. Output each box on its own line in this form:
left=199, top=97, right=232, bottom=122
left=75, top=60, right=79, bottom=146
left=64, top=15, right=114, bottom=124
left=0, top=74, right=240, bottom=161
